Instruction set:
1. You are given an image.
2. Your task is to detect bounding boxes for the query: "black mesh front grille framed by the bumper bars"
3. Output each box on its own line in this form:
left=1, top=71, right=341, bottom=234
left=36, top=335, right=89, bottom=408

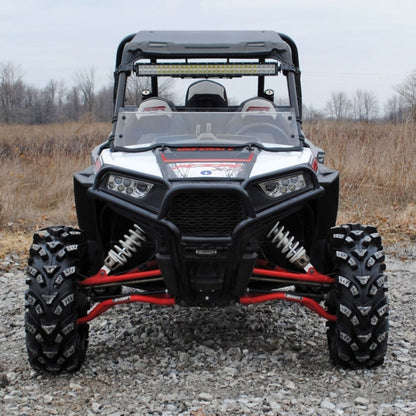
left=168, top=192, right=244, bottom=237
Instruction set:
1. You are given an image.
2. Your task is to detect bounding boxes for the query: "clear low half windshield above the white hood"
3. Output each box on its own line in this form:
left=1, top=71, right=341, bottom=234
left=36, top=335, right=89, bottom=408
left=114, top=107, right=300, bottom=150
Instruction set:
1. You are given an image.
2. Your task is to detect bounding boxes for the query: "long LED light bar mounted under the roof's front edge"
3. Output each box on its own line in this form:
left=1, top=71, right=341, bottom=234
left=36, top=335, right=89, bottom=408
left=136, top=63, right=278, bottom=78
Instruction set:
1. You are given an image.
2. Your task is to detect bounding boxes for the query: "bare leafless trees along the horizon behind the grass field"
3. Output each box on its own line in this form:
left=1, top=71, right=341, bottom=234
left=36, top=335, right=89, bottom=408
left=0, top=62, right=416, bottom=124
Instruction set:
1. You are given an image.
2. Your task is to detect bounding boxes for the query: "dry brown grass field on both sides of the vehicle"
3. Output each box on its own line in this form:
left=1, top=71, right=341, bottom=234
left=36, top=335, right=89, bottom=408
left=0, top=121, right=416, bottom=255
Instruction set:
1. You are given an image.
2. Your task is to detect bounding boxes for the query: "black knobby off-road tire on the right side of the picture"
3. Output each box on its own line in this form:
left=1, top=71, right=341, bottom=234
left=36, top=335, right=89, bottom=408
left=327, top=224, right=388, bottom=369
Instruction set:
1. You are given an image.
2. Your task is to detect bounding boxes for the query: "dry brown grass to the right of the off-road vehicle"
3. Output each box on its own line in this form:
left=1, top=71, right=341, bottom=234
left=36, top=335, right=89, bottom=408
left=305, top=122, right=416, bottom=242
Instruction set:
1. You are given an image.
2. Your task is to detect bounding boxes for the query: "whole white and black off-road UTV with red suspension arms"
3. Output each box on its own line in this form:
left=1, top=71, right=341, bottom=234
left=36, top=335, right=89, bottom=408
left=25, top=31, right=388, bottom=371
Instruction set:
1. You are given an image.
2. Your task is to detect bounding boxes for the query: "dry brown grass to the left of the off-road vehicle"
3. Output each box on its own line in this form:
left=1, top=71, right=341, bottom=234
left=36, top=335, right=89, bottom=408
left=0, top=121, right=111, bottom=258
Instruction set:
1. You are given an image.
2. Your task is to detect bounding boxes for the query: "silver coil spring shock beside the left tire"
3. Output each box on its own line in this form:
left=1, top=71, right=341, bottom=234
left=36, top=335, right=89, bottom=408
left=104, top=224, right=146, bottom=273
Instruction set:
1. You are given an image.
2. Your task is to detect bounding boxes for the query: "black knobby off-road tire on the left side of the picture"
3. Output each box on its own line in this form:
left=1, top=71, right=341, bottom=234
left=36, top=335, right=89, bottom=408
left=25, top=227, right=88, bottom=372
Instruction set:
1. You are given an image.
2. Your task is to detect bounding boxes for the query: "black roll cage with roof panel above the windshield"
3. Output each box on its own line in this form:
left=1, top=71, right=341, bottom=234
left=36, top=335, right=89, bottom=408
left=113, top=31, right=302, bottom=122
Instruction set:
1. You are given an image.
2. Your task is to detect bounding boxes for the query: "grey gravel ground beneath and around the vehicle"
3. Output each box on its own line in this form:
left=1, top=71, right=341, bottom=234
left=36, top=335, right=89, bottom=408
left=0, top=245, right=416, bottom=416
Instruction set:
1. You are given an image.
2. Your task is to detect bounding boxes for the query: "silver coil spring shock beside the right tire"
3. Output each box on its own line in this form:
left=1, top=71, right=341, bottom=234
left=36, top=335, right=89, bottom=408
left=267, top=221, right=312, bottom=271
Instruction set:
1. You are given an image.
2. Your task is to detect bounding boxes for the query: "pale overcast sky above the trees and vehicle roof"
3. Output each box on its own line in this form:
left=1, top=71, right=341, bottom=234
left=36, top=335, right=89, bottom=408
left=0, top=0, right=416, bottom=109
